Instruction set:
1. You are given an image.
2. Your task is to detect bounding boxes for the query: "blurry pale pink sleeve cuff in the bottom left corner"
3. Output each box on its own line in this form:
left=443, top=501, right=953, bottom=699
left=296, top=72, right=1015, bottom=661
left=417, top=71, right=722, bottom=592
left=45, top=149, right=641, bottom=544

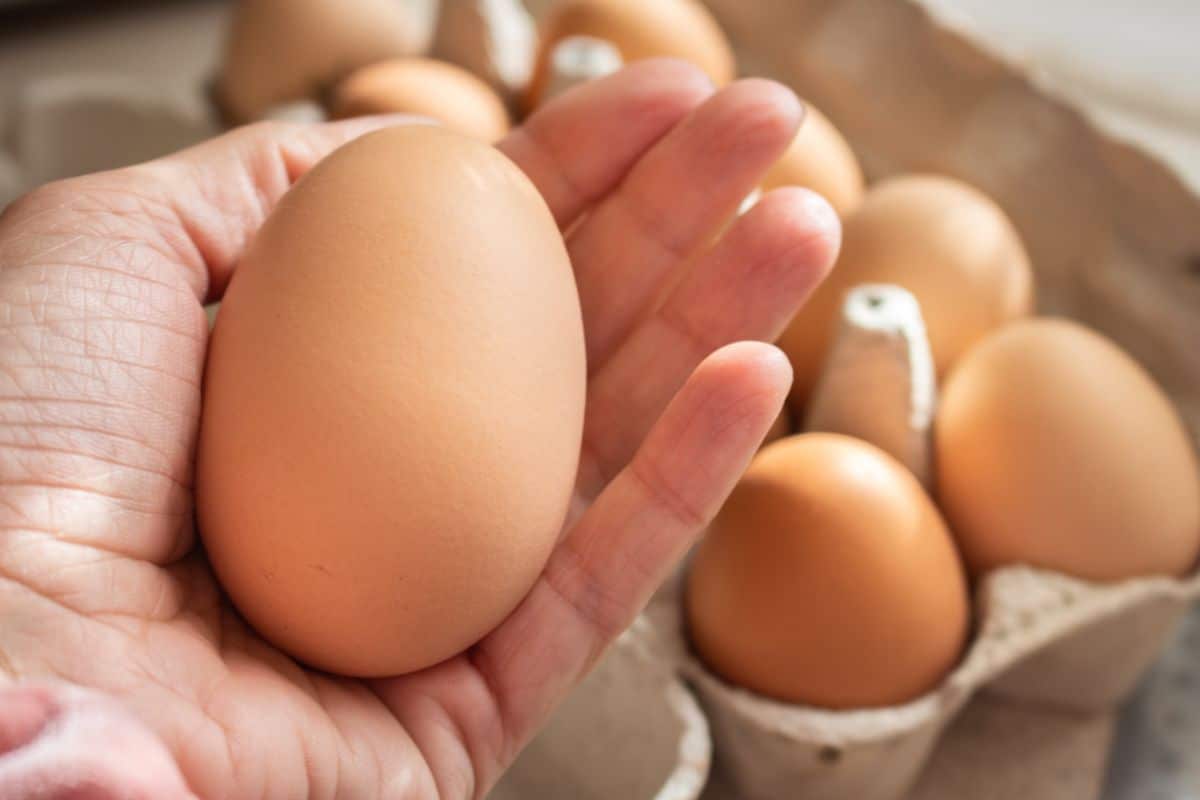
left=0, top=685, right=194, bottom=800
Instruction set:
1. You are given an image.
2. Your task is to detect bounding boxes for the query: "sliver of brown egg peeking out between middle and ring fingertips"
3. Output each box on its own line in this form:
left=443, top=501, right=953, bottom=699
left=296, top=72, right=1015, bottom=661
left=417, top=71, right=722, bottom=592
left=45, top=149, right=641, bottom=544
left=762, top=102, right=864, bottom=217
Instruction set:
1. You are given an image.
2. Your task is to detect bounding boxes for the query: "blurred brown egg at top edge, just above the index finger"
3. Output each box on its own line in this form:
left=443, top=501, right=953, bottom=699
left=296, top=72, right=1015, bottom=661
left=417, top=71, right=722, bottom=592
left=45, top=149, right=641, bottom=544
left=526, top=0, right=736, bottom=109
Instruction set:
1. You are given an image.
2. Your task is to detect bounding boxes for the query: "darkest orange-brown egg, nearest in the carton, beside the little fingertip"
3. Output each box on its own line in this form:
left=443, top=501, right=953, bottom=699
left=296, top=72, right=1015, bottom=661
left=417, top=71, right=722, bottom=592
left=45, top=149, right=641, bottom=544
left=686, top=433, right=968, bottom=709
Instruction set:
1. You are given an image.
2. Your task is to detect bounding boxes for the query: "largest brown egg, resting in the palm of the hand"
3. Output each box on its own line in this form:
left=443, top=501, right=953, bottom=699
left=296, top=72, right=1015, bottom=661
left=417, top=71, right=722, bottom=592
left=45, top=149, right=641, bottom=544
left=197, top=126, right=586, bottom=676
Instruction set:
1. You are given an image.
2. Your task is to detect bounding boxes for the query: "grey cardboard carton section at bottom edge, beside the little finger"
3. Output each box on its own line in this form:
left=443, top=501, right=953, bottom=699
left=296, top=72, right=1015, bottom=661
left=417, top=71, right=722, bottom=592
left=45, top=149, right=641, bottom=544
left=488, top=618, right=712, bottom=800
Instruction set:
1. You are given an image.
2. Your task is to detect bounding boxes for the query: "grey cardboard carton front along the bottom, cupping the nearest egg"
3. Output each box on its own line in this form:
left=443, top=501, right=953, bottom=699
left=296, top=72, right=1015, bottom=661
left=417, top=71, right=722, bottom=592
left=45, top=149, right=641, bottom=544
left=491, top=556, right=1200, bottom=800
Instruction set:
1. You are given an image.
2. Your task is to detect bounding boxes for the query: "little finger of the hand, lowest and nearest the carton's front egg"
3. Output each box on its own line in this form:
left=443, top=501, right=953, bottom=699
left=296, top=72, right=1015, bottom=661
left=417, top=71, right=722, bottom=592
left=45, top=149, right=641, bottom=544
left=458, top=343, right=791, bottom=756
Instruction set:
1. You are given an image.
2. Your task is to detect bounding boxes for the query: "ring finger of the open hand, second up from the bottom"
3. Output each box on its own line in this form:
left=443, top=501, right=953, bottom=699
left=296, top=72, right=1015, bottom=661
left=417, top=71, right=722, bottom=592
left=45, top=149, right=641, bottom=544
left=580, top=188, right=841, bottom=497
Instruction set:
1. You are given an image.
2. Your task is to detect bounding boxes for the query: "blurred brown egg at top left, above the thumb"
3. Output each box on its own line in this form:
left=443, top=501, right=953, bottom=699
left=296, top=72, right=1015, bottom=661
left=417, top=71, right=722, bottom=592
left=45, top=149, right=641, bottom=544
left=216, top=0, right=431, bottom=125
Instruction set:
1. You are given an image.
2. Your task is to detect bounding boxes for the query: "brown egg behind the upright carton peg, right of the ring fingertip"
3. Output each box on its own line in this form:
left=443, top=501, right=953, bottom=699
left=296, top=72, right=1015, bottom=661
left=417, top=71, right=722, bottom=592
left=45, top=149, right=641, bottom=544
left=779, top=175, right=1033, bottom=410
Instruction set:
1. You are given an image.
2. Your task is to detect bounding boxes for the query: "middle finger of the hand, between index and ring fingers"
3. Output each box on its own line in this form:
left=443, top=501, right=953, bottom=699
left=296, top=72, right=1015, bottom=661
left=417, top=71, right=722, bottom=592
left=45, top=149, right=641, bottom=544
left=569, top=80, right=803, bottom=371
